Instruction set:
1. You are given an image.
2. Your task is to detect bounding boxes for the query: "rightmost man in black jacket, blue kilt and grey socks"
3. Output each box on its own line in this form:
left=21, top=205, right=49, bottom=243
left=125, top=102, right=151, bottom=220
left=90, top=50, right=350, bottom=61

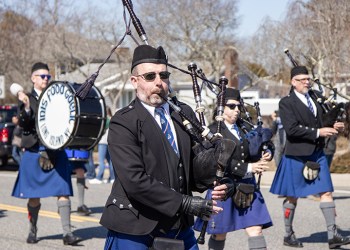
left=270, top=66, right=350, bottom=248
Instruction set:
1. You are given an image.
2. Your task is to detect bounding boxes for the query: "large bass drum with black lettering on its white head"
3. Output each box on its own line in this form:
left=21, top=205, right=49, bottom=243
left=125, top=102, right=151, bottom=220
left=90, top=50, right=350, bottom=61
left=36, top=81, right=106, bottom=150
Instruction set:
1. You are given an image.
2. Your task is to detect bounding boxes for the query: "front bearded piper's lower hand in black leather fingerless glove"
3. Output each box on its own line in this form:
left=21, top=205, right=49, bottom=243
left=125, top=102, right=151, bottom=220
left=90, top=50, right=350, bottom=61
left=181, top=195, right=222, bottom=221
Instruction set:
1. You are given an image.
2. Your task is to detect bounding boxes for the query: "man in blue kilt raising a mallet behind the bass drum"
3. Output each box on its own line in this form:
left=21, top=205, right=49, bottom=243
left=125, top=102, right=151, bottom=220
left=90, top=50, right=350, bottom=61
left=11, top=62, right=82, bottom=245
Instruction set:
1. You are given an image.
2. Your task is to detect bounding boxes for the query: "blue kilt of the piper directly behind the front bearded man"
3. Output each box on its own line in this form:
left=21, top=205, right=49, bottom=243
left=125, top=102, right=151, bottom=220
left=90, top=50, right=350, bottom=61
left=194, top=177, right=272, bottom=234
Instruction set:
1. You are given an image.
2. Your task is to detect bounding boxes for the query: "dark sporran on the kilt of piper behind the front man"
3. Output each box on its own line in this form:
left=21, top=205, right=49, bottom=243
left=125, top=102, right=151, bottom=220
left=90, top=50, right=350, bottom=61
left=233, top=183, right=255, bottom=208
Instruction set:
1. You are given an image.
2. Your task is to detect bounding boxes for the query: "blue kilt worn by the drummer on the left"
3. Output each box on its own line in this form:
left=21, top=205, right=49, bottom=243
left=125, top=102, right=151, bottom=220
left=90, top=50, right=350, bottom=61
left=12, top=150, right=73, bottom=198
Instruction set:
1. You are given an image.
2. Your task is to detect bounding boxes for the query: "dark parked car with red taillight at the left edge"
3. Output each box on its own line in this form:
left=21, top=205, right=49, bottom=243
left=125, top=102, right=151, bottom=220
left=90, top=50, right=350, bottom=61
left=0, top=105, right=17, bottom=166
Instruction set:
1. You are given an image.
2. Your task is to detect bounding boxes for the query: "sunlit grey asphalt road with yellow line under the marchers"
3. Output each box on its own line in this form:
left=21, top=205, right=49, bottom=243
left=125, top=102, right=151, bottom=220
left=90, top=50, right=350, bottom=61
left=0, top=166, right=350, bottom=250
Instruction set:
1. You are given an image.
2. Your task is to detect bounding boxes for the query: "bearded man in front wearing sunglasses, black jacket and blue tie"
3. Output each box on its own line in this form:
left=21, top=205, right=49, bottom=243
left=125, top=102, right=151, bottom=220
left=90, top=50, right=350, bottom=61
left=100, top=45, right=237, bottom=250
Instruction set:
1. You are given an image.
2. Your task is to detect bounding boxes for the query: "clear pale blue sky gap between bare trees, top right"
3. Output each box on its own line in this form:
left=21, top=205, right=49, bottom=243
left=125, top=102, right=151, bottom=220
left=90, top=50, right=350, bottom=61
left=237, top=0, right=289, bottom=37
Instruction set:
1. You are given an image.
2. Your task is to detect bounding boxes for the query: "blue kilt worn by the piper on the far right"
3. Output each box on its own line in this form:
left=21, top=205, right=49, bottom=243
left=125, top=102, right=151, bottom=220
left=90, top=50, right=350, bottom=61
left=270, top=150, right=334, bottom=198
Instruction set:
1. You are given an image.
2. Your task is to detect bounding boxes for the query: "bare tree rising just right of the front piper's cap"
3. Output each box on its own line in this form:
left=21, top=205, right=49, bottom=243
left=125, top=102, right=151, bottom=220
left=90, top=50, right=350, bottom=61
left=135, top=0, right=238, bottom=79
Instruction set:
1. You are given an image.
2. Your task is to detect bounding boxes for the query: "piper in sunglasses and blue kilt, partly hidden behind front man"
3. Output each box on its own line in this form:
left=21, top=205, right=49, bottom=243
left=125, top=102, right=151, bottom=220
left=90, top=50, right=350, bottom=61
left=194, top=88, right=272, bottom=250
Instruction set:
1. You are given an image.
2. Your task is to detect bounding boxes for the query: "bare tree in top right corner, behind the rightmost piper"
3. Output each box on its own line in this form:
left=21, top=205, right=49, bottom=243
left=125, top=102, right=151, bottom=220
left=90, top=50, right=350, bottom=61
left=243, top=0, right=350, bottom=90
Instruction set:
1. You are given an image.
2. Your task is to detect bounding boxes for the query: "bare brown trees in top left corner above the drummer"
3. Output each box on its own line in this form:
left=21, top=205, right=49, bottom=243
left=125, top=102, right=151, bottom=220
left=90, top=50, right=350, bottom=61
left=0, top=0, right=126, bottom=102
